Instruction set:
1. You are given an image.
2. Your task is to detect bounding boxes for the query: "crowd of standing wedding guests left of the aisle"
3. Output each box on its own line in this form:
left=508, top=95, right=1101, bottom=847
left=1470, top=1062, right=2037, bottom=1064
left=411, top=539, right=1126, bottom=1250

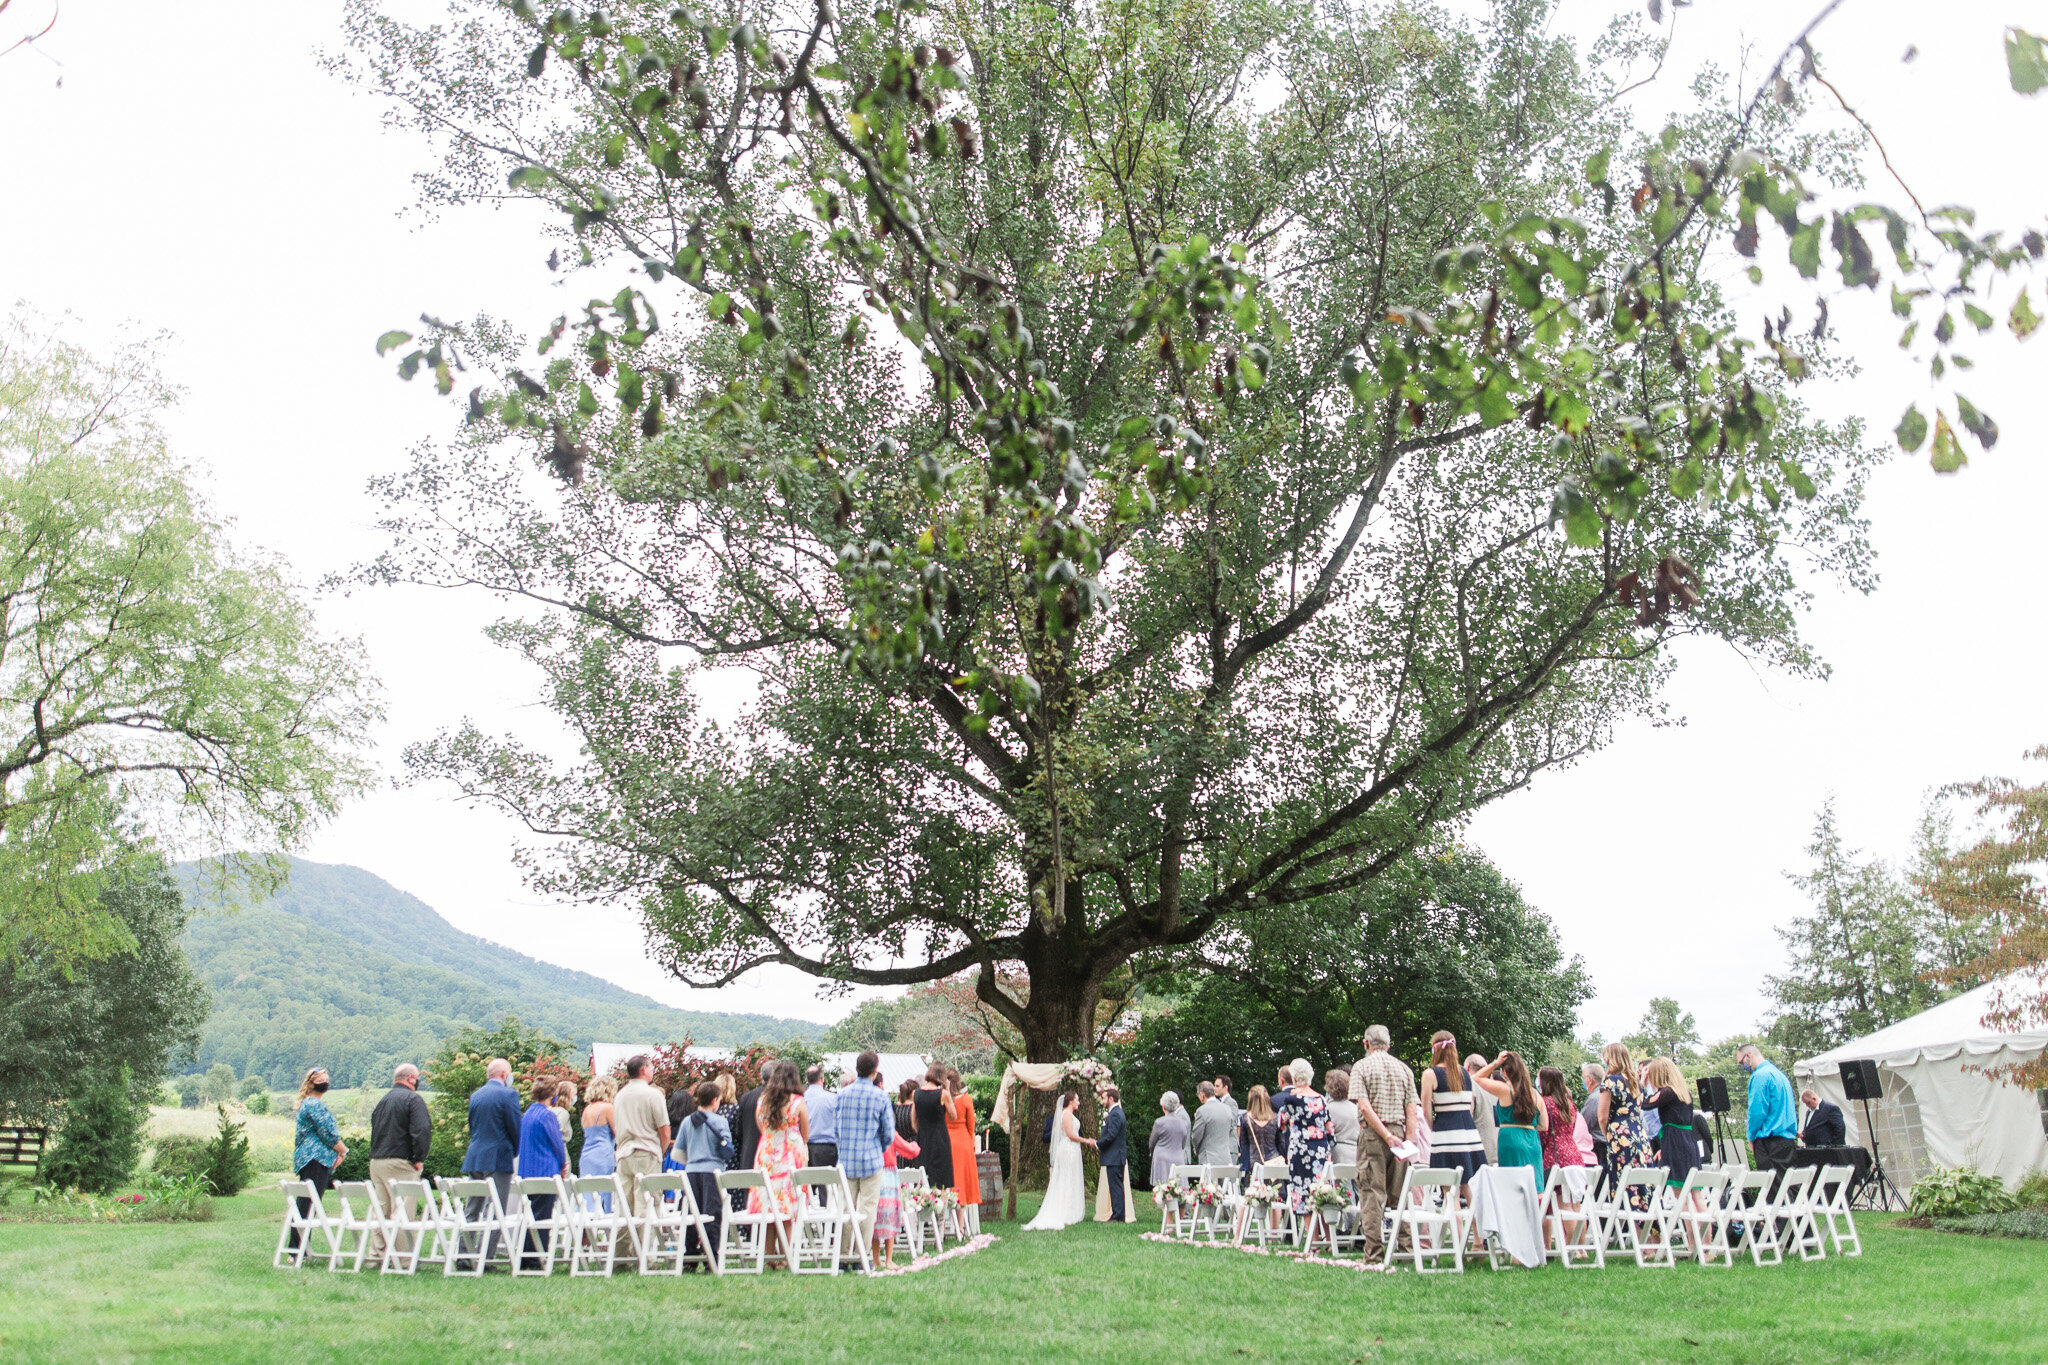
left=293, top=1052, right=981, bottom=1267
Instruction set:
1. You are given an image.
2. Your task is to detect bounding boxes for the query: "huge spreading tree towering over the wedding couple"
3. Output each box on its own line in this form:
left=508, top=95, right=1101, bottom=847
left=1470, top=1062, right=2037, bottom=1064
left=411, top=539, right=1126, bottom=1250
left=338, top=0, right=2040, bottom=1060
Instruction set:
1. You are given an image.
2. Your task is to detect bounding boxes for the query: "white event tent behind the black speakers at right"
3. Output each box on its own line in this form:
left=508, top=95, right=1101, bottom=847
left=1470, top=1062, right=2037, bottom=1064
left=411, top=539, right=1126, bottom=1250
left=1794, top=976, right=2048, bottom=1189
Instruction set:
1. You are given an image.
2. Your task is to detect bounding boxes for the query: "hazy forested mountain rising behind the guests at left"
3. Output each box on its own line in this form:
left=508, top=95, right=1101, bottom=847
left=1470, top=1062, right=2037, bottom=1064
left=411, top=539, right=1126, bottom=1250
left=176, top=857, right=825, bottom=1087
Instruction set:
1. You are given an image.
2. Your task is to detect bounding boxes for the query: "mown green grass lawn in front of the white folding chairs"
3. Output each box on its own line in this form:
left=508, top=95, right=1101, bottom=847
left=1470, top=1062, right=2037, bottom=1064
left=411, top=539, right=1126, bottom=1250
left=0, top=1193, right=2048, bottom=1365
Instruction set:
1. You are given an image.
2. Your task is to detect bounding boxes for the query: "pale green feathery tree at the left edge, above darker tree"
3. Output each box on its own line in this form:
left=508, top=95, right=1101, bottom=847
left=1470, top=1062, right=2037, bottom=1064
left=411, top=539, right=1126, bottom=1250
left=0, top=315, right=377, bottom=961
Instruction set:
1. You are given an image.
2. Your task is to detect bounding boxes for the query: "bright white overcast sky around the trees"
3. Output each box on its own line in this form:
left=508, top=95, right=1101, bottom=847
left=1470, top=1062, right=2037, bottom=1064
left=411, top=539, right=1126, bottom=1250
left=0, top=0, right=2048, bottom=1038
